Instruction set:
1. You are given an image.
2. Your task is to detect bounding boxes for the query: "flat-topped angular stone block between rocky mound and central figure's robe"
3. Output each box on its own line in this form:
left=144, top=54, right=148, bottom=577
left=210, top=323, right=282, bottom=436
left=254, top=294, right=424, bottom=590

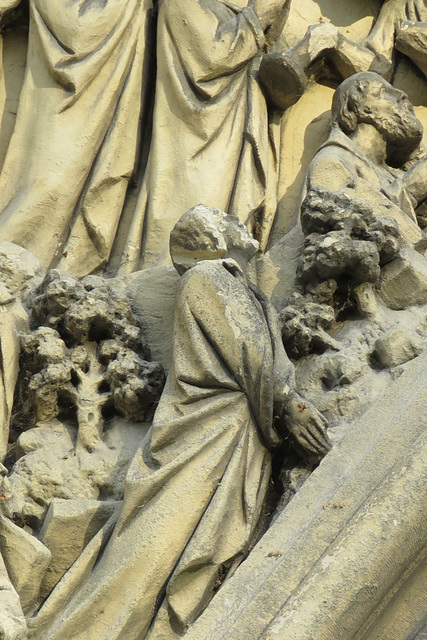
left=38, top=499, right=120, bottom=599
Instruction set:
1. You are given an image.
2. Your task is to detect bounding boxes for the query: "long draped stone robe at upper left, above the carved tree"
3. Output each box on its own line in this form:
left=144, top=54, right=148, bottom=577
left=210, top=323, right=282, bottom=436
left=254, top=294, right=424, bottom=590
left=0, top=0, right=152, bottom=276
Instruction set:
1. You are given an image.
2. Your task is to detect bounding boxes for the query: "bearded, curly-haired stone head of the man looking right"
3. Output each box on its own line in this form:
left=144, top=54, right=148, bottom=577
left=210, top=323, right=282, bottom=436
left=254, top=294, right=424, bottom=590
left=332, top=71, right=423, bottom=163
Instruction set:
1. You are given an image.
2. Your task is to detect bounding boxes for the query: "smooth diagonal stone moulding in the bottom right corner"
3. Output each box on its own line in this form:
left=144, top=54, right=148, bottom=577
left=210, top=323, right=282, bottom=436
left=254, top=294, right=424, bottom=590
left=186, top=355, right=427, bottom=640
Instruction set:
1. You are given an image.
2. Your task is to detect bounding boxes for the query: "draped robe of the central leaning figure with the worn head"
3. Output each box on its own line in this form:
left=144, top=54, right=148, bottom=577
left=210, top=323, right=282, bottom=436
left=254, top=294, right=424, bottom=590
left=31, top=261, right=293, bottom=640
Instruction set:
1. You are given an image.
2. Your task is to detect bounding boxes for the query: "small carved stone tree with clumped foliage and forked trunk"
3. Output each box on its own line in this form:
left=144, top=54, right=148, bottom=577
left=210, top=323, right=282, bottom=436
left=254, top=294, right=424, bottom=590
left=15, top=271, right=164, bottom=450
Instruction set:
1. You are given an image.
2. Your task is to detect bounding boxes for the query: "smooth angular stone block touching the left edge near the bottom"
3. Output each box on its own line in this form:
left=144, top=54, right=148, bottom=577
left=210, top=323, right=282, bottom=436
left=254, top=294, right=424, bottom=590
left=0, top=516, right=52, bottom=616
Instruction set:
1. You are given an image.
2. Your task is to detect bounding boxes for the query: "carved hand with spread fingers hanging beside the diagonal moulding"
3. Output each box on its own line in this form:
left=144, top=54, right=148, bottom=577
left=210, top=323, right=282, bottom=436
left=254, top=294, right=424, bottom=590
left=284, top=394, right=331, bottom=458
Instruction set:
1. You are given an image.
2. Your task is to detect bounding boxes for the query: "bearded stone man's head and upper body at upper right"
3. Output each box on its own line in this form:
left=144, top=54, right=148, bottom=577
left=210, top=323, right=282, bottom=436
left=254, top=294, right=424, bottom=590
left=306, top=72, right=427, bottom=244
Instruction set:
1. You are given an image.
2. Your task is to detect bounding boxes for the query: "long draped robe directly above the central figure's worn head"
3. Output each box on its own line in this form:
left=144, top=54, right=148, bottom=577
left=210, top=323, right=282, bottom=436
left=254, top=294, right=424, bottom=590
left=113, top=0, right=276, bottom=272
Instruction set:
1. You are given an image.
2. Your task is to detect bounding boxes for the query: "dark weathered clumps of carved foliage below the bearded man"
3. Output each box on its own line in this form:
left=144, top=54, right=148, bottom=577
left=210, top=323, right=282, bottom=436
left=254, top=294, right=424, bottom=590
left=281, top=187, right=400, bottom=357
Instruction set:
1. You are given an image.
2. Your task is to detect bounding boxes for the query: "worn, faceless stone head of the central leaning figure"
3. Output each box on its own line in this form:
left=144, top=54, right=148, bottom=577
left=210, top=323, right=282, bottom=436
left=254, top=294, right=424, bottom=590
left=170, top=204, right=259, bottom=275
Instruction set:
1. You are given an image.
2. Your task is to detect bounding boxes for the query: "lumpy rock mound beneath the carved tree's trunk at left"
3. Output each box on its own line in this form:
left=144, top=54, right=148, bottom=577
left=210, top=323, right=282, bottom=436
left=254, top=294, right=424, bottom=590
left=2, top=418, right=149, bottom=529
